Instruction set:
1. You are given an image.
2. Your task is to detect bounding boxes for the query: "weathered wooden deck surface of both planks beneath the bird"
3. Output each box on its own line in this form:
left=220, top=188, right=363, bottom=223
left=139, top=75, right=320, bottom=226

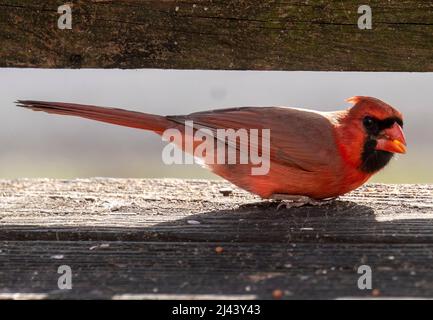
left=0, top=179, right=433, bottom=299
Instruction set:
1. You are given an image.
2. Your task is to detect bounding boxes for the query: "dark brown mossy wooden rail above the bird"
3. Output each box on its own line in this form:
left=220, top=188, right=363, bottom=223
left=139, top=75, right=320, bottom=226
left=0, top=0, right=433, bottom=71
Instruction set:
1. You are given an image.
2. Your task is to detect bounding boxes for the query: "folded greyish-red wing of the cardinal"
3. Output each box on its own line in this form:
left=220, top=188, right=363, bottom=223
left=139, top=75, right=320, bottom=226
left=167, top=107, right=338, bottom=171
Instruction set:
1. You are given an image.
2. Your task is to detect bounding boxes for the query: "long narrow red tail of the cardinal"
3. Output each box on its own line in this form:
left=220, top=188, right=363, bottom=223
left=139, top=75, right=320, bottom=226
left=16, top=100, right=173, bottom=133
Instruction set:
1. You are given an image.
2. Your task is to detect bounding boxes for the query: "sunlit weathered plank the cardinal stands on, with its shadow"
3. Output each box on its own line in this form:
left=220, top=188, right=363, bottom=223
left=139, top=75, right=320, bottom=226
left=0, top=179, right=433, bottom=243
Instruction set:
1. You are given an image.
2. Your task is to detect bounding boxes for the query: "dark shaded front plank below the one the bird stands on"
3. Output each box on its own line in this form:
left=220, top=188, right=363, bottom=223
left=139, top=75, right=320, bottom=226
left=0, top=241, right=433, bottom=299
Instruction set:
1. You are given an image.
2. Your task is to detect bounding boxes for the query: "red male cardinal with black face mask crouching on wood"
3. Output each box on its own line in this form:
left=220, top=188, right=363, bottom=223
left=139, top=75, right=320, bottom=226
left=17, top=96, right=406, bottom=205
